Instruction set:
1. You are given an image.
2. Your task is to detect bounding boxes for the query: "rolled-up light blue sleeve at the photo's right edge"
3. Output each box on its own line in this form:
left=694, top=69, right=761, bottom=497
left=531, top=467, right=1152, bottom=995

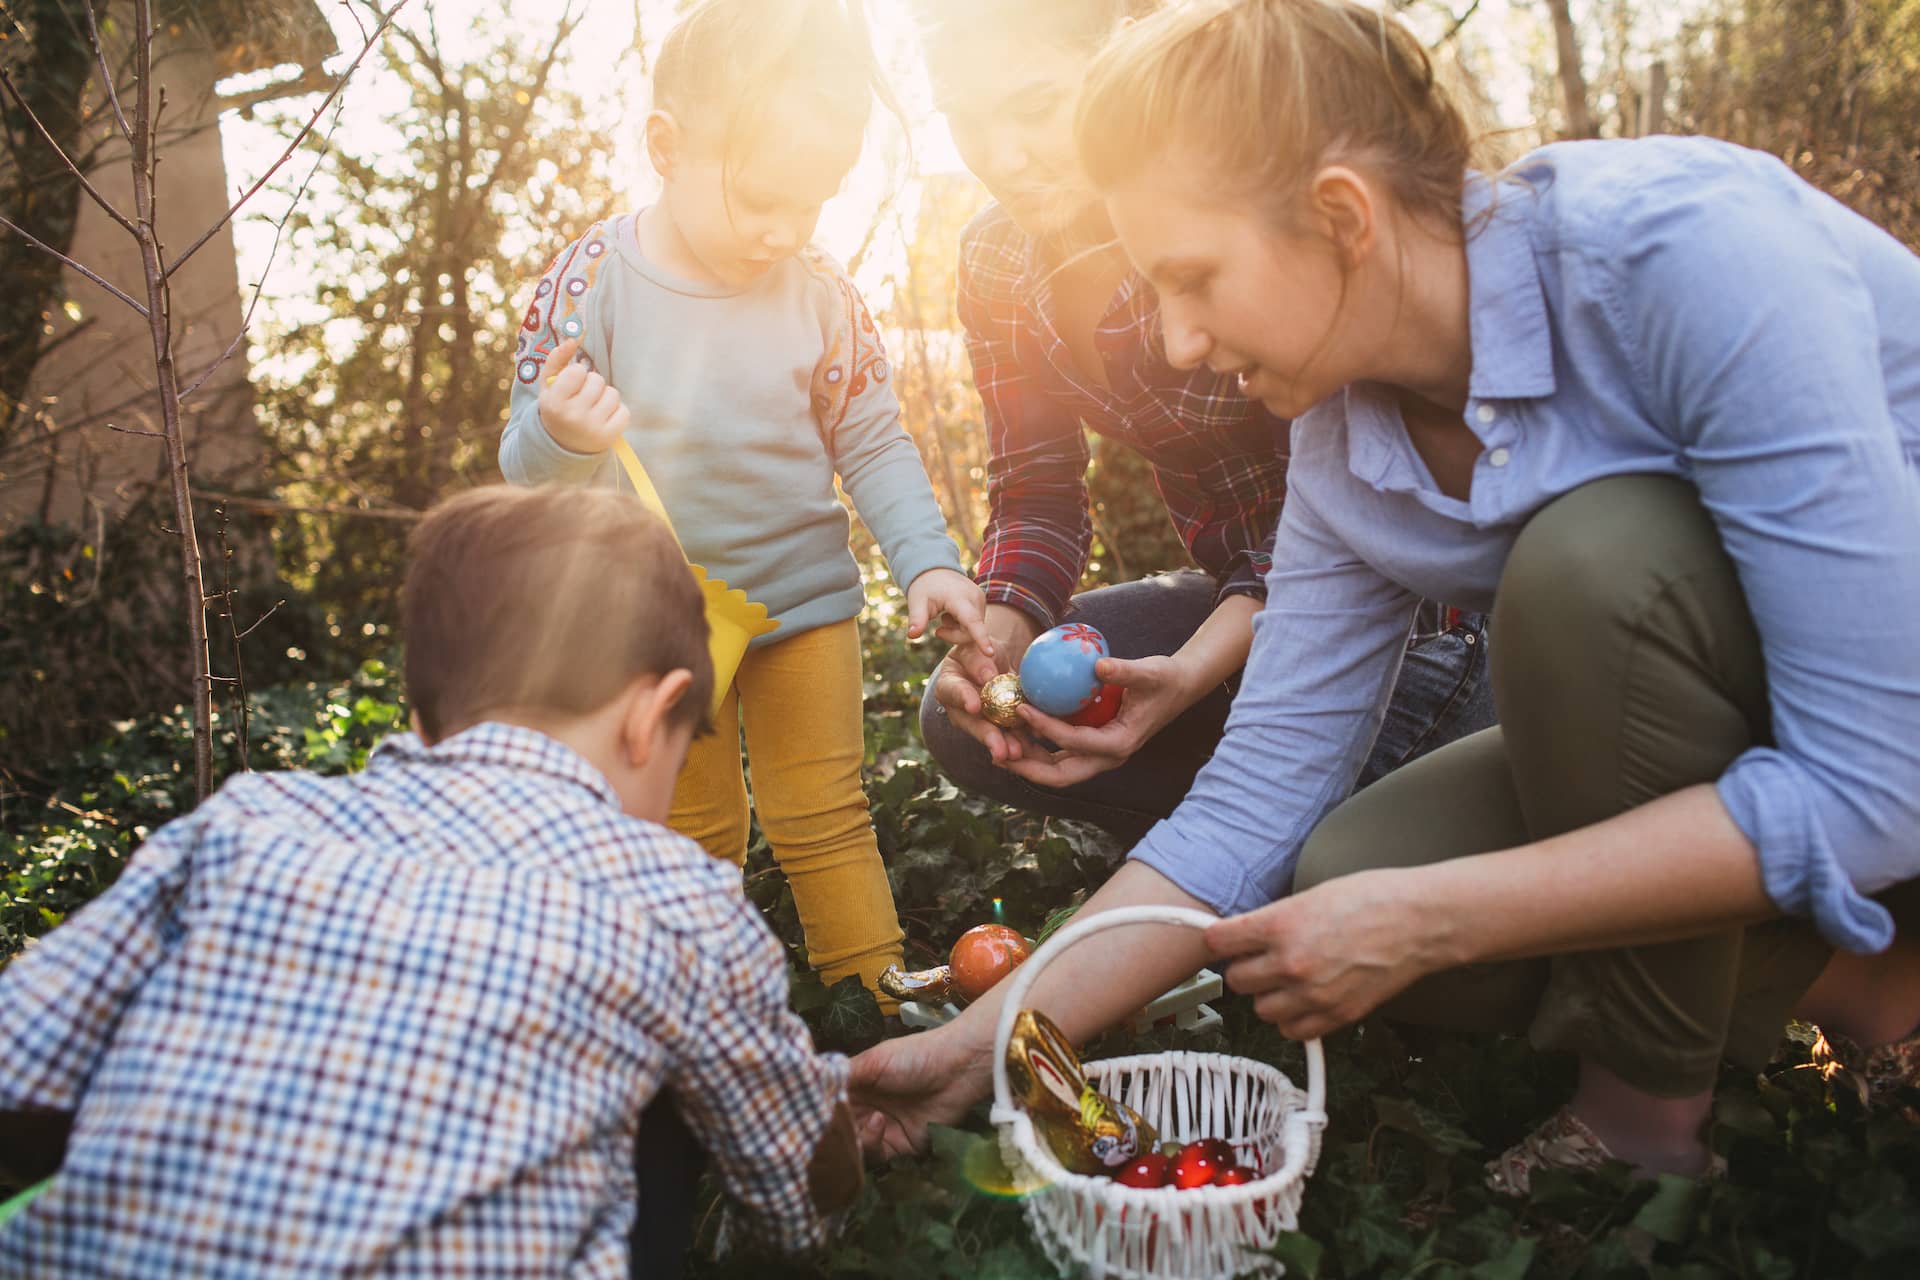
left=1612, top=161, right=1920, bottom=950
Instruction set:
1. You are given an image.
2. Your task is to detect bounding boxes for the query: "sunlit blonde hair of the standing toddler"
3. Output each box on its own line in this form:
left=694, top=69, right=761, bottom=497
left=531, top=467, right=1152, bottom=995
left=653, top=0, right=906, bottom=192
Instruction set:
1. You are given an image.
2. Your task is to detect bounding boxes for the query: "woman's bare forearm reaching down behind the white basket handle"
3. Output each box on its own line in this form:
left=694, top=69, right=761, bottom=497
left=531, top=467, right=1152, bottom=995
left=933, top=862, right=1208, bottom=1094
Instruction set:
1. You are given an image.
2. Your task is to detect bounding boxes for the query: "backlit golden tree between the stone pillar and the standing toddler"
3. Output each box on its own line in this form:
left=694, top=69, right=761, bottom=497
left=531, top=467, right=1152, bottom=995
left=255, top=6, right=614, bottom=640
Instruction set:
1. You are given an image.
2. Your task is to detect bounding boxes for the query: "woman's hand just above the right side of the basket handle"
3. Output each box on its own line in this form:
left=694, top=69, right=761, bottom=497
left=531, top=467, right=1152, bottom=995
left=1206, top=869, right=1459, bottom=1040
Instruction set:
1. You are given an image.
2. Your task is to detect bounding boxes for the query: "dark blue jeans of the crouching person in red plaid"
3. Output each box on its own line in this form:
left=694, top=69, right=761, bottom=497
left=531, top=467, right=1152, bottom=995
left=920, top=570, right=1494, bottom=844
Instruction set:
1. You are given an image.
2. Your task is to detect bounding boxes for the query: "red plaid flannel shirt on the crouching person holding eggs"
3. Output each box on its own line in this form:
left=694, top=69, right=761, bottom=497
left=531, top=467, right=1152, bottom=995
left=958, top=205, right=1288, bottom=626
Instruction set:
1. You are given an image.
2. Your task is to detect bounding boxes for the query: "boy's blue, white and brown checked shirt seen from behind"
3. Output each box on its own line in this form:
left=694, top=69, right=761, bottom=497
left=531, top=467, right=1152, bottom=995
left=0, top=723, right=847, bottom=1276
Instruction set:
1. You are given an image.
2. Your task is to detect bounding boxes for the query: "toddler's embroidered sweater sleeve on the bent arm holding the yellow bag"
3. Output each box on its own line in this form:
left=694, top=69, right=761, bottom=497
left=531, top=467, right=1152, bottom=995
left=499, top=223, right=616, bottom=486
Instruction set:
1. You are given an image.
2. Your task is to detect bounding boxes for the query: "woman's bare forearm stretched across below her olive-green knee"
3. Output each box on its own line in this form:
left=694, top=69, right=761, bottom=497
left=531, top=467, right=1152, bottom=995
left=1404, top=785, right=1780, bottom=969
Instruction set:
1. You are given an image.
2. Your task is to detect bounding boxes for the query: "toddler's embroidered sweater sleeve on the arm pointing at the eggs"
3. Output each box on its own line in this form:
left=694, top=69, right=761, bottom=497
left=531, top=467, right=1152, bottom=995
left=808, top=249, right=962, bottom=589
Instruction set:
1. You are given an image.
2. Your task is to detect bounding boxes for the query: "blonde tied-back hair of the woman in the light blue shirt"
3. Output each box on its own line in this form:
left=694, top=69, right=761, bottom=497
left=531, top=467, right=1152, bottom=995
left=1073, top=0, right=1475, bottom=235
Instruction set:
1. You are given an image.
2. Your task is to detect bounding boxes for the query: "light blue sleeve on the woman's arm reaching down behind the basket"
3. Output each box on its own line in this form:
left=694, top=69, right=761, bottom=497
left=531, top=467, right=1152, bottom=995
left=1131, top=475, right=1417, bottom=915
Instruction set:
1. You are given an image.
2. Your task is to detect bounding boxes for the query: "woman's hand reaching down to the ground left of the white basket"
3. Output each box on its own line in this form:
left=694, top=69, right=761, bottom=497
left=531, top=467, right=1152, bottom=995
left=847, top=1025, right=993, bottom=1157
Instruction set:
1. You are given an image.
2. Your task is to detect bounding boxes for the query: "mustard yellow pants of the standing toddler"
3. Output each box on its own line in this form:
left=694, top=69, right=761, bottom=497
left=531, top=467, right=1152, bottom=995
left=668, top=618, right=902, bottom=986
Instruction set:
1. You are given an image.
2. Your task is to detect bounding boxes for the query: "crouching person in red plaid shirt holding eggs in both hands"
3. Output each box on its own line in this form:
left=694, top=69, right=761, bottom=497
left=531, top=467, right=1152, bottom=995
left=920, top=0, right=1492, bottom=841
